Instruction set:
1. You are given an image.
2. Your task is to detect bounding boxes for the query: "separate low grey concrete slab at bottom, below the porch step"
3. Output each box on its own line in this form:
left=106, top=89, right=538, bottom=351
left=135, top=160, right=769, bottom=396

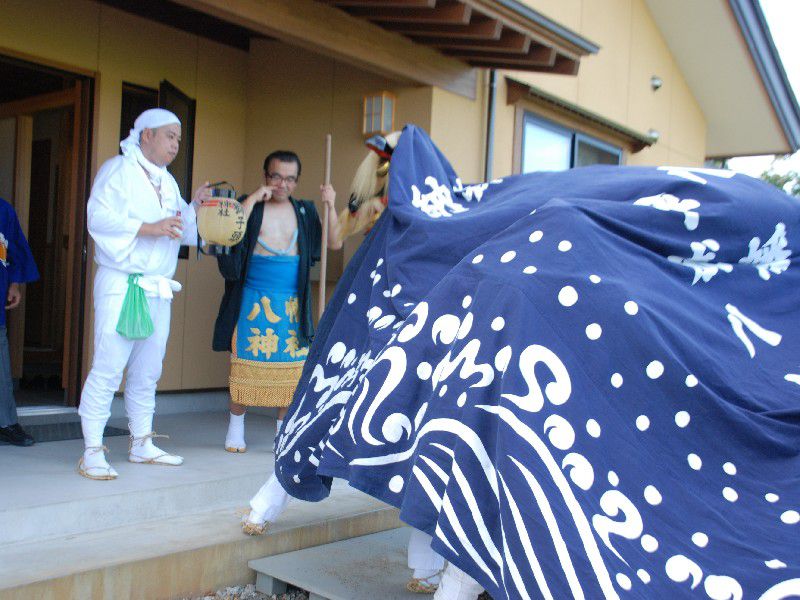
left=253, top=527, right=420, bottom=600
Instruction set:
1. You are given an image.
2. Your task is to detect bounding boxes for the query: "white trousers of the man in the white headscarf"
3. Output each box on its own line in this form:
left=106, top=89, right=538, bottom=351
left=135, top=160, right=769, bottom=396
left=78, top=281, right=172, bottom=447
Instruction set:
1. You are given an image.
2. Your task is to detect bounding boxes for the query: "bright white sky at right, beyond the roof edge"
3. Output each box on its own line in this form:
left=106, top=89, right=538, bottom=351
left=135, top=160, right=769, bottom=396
left=728, top=0, right=800, bottom=177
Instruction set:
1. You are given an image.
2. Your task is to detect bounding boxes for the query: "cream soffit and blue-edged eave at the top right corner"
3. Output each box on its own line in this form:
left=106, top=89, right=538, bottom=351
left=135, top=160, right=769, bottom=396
left=645, top=0, right=800, bottom=157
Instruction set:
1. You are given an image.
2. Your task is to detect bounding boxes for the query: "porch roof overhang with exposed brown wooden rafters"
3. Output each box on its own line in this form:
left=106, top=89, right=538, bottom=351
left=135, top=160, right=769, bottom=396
left=319, top=0, right=599, bottom=75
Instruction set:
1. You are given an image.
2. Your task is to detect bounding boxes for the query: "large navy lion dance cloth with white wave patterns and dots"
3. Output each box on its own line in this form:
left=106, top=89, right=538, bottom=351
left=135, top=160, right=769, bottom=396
left=276, top=126, right=800, bottom=600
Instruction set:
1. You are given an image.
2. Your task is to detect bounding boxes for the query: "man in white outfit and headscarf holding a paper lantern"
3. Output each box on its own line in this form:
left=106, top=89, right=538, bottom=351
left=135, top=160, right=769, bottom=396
left=78, top=108, right=210, bottom=479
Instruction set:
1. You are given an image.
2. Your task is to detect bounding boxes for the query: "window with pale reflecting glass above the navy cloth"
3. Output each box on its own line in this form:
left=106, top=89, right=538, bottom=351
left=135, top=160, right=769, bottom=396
left=521, top=112, right=622, bottom=173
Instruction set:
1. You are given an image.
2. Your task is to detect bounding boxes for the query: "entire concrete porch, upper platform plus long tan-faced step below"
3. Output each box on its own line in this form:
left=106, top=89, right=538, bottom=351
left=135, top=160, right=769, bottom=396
left=0, top=411, right=399, bottom=600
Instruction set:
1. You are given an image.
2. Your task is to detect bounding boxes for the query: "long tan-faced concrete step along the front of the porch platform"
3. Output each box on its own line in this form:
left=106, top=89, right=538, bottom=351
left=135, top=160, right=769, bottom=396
left=0, top=483, right=400, bottom=600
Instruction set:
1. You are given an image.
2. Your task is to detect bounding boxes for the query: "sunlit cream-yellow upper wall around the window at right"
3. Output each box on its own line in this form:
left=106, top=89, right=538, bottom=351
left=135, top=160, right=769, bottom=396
left=494, top=0, right=706, bottom=176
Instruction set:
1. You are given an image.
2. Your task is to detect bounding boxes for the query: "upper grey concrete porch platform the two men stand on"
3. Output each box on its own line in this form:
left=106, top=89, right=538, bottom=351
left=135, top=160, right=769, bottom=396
left=0, top=412, right=282, bottom=544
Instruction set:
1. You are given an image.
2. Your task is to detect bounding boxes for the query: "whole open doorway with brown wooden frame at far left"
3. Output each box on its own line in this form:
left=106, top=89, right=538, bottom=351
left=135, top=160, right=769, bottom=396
left=0, top=55, right=92, bottom=407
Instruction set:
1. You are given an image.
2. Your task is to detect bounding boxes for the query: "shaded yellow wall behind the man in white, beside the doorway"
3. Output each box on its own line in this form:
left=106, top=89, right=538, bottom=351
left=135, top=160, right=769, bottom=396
left=0, top=0, right=247, bottom=390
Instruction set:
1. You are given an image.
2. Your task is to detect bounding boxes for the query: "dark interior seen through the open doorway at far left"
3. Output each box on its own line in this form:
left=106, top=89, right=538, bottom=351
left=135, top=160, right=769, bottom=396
left=0, top=56, right=81, bottom=406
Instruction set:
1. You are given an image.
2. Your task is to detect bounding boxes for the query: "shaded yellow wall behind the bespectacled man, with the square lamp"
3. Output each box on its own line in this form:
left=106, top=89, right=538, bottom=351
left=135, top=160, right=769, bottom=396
left=244, top=41, right=438, bottom=278
